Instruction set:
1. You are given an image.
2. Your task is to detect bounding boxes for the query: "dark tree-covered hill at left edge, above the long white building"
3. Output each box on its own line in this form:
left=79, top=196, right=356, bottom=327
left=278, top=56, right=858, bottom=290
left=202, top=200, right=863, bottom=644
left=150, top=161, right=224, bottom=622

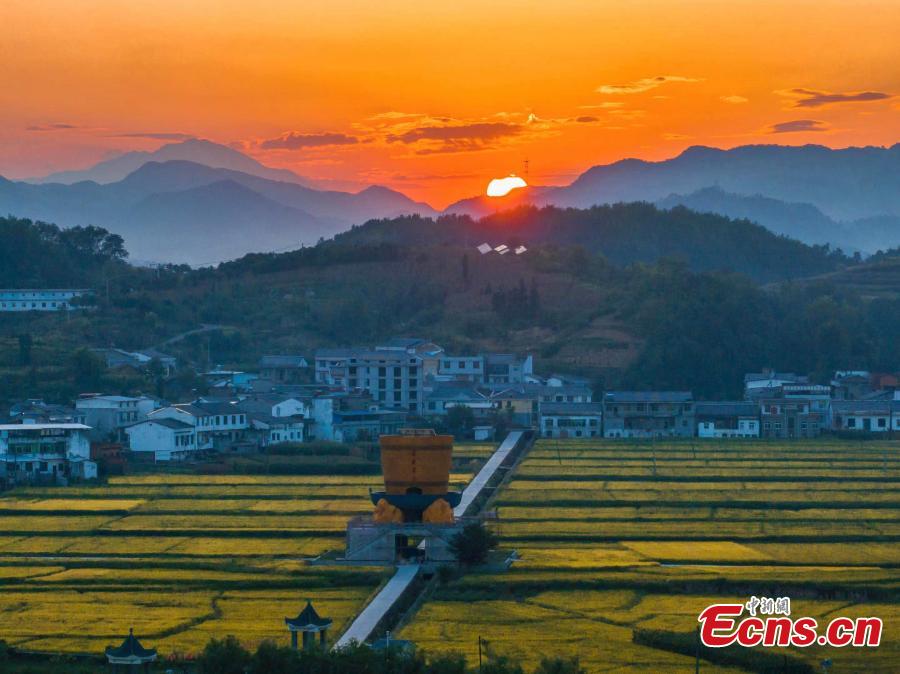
left=0, top=217, right=128, bottom=288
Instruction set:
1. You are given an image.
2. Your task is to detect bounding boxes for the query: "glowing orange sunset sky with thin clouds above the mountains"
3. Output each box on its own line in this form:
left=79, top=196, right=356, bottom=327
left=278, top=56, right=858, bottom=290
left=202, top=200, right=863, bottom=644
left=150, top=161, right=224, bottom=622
left=0, top=0, right=900, bottom=207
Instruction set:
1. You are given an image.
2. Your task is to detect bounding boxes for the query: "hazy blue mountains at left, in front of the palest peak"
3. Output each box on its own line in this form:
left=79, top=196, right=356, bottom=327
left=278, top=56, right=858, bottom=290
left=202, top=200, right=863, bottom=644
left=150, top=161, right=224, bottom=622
left=0, top=150, right=435, bottom=265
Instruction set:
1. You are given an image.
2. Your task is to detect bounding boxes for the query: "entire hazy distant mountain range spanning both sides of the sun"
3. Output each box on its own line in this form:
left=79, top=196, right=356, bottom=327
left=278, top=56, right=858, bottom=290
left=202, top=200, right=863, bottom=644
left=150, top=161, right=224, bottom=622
left=0, top=139, right=900, bottom=264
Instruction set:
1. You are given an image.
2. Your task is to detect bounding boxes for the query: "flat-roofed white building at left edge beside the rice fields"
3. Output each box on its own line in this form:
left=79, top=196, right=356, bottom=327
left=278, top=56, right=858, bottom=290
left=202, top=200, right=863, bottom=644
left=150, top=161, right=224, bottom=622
left=0, top=424, right=97, bottom=482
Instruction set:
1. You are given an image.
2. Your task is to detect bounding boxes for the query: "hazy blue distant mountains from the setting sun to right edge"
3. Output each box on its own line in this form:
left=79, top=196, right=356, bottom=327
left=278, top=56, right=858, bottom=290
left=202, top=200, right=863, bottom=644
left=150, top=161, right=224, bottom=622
left=447, top=144, right=900, bottom=252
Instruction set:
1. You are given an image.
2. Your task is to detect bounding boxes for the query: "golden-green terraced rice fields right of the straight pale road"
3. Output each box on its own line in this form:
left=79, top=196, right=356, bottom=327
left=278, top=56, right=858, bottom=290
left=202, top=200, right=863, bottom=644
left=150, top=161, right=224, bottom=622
left=400, top=440, right=900, bottom=672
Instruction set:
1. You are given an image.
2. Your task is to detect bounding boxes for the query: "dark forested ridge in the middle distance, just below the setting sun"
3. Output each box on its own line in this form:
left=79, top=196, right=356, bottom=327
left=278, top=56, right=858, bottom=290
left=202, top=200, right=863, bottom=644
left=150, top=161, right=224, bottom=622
left=335, top=203, right=848, bottom=282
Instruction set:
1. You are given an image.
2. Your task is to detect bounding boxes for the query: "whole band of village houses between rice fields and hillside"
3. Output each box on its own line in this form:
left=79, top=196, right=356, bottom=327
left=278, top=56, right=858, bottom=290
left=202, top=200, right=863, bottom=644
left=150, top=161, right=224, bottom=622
left=0, top=339, right=900, bottom=480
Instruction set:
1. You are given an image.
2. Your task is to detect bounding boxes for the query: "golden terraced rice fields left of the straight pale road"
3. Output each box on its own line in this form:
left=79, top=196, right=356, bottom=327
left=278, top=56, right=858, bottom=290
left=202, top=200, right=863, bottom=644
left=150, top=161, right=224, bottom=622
left=0, top=474, right=470, bottom=656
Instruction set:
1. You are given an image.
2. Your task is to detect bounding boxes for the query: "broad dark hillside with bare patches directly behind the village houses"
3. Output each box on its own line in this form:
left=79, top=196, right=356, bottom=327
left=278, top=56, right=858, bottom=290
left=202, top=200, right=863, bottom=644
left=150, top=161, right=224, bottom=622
left=0, top=214, right=900, bottom=399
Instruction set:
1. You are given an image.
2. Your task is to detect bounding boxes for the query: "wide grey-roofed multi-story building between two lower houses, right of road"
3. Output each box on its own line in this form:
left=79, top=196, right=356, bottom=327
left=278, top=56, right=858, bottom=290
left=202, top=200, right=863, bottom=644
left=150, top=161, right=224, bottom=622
left=603, top=391, right=694, bottom=438
